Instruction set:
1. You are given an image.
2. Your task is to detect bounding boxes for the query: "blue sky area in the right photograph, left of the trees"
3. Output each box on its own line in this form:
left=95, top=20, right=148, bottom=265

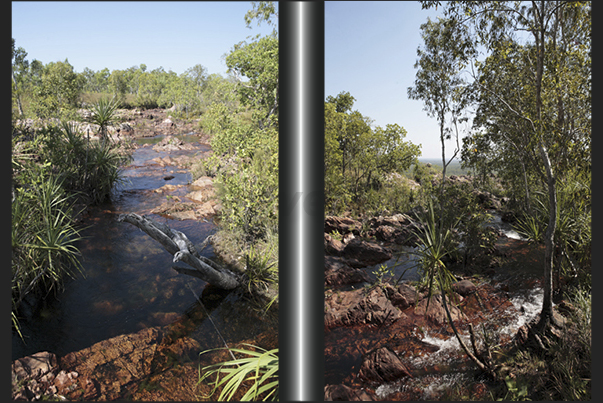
left=325, top=1, right=462, bottom=159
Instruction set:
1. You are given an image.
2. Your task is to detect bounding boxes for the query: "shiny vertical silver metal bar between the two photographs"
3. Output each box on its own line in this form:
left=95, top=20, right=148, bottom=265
left=279, top=2, right=324, bottom=401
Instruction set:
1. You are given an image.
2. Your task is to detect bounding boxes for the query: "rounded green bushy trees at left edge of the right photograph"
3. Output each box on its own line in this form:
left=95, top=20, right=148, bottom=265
left=324, top=93, right=420, bottom=214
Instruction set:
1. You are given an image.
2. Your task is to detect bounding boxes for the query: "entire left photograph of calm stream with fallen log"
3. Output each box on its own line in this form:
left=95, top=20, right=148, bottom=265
left=10, top=2, right=279, bottom=401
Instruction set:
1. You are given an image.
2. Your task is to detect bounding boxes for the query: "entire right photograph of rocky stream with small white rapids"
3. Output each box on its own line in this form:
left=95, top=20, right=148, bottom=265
left=324, top=1, right=592, bottom=401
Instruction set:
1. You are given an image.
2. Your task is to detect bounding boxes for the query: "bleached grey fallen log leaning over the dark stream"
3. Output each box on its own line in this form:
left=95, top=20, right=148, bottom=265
left=117, top=213, right=240, bottom=290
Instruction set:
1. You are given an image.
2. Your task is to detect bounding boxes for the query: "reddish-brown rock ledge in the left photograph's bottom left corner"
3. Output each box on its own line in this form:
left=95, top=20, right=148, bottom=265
left=12, top=327, right=200, bottom=400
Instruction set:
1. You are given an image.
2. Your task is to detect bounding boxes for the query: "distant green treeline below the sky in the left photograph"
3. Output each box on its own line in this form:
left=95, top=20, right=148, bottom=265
left=11, top=39, right=237, bottom=119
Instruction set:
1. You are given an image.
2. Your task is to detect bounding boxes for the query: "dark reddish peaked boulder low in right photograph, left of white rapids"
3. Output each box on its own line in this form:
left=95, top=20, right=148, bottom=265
left=358, top=347, right=411, bottom=383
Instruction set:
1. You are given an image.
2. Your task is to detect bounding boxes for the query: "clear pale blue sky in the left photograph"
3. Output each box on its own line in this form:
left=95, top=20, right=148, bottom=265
left=12, top=1, right=272, bottom=75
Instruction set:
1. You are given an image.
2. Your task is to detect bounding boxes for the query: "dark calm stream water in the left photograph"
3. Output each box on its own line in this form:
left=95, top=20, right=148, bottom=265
left=12, top=136, right=275, bottom=360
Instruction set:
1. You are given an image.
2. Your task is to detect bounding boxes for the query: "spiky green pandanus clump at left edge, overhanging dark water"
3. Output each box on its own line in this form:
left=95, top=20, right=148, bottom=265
left=11, top=163, right=81, bottom=333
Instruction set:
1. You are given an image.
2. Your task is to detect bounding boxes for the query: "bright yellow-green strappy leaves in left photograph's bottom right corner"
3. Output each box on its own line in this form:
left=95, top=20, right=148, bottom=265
left=199, top=345, right=279, bottom=401
